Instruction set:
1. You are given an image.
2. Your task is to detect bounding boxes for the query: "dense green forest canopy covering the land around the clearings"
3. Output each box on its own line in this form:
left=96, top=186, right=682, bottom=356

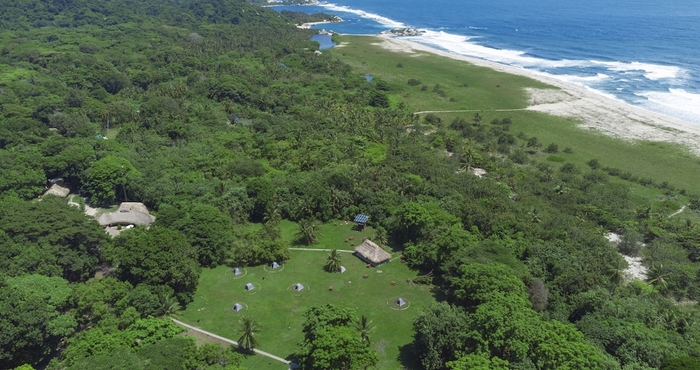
left=0, top=0, right=700, bottom=369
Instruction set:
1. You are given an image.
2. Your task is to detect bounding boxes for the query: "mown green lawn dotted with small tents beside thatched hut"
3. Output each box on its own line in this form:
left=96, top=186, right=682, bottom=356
left=179, top=221, right=435, bottom=369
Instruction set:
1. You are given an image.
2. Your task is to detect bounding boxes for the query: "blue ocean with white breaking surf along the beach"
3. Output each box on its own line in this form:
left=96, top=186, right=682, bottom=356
left=273, top=0, right=700, bottom=125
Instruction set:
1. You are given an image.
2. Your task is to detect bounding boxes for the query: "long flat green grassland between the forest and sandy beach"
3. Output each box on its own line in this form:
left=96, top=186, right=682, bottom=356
left=329, top=36, right=700, bottom=195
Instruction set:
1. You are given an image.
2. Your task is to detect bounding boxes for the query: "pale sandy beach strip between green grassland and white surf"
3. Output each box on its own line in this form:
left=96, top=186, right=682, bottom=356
left=378, top=35, right=700, bottom=155
